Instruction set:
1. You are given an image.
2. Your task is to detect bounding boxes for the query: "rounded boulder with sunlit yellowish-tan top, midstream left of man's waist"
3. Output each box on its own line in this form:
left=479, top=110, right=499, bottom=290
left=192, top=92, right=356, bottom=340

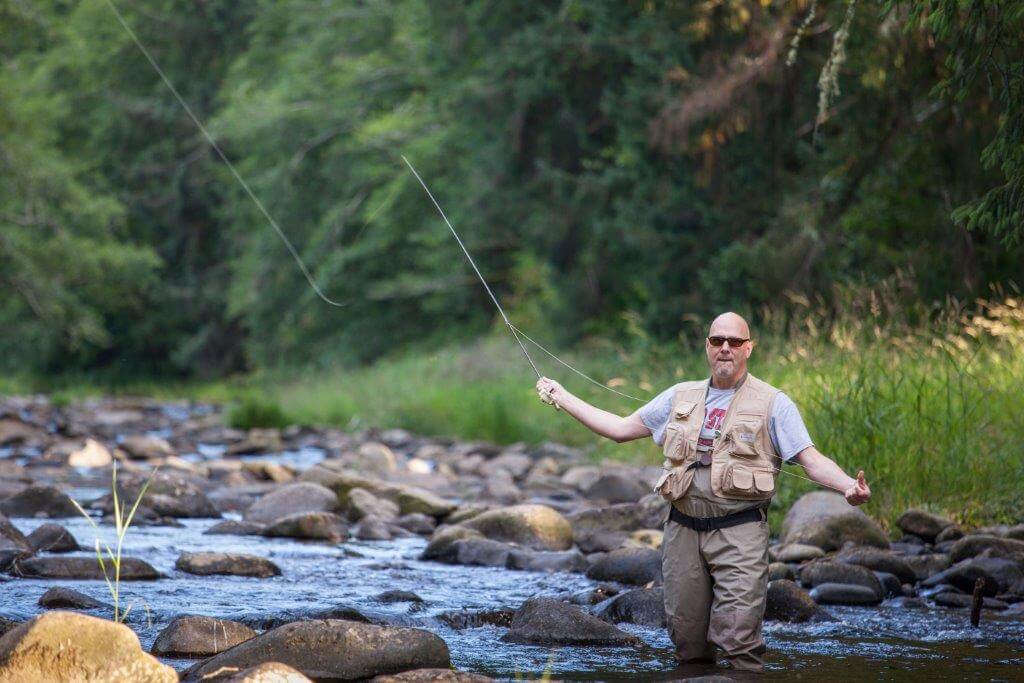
left=462, top=505, right=572, bottom=550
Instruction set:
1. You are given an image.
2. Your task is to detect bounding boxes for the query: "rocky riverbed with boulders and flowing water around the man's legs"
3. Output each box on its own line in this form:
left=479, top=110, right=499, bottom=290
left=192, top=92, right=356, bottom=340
left=0, top=398, right=1024, bottom=680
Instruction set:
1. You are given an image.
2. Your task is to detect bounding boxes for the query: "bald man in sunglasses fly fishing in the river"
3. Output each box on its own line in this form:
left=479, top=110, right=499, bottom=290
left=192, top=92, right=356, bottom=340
left=537, top=312, right=871, bottom=671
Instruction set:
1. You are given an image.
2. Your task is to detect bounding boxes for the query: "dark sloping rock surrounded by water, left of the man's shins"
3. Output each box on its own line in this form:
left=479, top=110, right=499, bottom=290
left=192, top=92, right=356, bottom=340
left=502, top=598, right=641, bottom=647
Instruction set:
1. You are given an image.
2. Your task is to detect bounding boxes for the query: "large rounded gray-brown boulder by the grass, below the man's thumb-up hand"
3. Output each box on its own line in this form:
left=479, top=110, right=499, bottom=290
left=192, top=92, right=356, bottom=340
left=782, top=490, right=889, bottom=551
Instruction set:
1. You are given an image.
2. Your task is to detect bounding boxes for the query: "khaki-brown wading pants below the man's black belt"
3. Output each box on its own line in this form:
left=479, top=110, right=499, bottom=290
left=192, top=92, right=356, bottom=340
left=662, top=509, right=768, bottom=671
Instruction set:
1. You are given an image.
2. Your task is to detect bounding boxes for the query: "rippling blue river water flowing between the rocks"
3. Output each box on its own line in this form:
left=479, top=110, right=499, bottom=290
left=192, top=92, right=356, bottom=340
left=0, top=519, right=1024, bottom=681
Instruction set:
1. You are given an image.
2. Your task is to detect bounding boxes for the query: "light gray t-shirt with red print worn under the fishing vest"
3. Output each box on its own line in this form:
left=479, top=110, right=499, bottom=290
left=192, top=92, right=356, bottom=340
left=639, top=384, right=814, bottom=461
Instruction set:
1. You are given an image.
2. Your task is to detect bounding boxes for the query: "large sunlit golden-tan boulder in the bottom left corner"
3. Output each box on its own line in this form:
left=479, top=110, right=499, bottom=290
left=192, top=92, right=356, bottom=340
left=0, top=611, right=178, bottom=683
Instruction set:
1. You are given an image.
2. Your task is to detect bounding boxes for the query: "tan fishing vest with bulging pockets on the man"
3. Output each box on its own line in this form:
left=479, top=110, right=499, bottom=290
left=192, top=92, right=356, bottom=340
left=654, top=374, right=781, bottom=501
